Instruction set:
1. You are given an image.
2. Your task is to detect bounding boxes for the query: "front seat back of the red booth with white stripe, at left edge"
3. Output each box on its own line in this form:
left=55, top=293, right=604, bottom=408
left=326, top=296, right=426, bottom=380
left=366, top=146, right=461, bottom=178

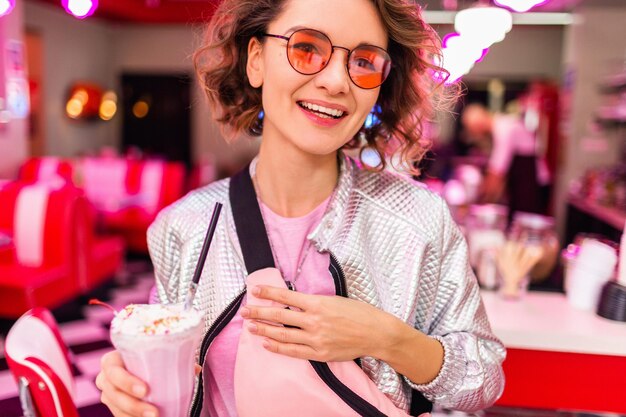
left=0, top=183, right=79, bottom=317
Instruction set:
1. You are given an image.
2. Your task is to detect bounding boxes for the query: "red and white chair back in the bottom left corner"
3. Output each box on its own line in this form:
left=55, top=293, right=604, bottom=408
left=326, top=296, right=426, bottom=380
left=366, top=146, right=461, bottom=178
left=5, top=308, right=79, bottom=417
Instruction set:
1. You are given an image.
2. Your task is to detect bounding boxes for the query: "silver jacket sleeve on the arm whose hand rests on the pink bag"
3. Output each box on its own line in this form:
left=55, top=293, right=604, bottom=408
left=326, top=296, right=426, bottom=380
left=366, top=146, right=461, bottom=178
left=405, top=197, right=506, bottom=412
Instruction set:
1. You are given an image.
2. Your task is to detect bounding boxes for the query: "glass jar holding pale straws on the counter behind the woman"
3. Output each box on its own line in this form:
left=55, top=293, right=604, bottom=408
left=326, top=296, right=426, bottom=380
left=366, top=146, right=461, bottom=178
left=498, top=212, right=559, bottom=298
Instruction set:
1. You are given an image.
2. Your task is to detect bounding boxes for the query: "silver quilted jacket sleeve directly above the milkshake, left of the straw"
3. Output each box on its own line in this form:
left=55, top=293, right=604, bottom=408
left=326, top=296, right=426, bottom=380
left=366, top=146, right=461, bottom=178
left=147, top=206, right=182, bottom=303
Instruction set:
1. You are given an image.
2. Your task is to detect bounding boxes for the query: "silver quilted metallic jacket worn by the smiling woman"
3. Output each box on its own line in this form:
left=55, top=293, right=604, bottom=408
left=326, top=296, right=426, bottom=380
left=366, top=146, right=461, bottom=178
left=148, top=158, right=506, bottom=411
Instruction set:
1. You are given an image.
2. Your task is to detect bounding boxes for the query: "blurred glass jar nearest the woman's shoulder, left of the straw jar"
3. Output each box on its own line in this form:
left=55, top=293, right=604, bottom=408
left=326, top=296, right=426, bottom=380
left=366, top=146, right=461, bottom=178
left=465, top=204, right=508, bottom=290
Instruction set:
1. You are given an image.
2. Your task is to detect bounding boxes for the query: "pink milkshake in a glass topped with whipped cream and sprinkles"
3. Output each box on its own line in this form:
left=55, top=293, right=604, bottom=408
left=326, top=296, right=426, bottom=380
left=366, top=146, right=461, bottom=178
left=111, top=304, right=202, bottom=417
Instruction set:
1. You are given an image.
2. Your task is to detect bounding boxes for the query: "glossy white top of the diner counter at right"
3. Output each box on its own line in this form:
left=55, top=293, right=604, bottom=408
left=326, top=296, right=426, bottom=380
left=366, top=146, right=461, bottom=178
left=481, top=291, right=626, bottom=356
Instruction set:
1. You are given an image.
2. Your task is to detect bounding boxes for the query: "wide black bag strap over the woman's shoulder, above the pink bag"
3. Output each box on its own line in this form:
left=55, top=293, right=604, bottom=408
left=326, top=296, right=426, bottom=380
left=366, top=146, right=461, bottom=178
left=228, top=165, right=274, bottom=274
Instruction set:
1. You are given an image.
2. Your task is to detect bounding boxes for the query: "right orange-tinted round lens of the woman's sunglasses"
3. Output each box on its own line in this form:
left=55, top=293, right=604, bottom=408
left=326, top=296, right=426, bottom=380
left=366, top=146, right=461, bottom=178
left=348, top=45, right=391, bottom=88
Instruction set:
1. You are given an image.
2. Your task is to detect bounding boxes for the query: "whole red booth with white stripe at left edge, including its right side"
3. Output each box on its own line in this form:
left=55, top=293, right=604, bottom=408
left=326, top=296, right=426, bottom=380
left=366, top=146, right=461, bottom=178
left=0, top=182, right=124, bottom=318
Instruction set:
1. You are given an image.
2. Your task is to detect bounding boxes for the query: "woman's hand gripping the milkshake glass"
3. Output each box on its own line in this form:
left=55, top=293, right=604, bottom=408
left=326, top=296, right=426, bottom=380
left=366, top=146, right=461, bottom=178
left=96, top=351, right=159, bottom=417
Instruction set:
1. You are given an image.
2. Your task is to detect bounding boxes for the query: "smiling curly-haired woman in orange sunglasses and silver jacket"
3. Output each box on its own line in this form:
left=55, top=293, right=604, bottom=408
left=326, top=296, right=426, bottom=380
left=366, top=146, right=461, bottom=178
left=97, top=0, right=505, bottom=417
